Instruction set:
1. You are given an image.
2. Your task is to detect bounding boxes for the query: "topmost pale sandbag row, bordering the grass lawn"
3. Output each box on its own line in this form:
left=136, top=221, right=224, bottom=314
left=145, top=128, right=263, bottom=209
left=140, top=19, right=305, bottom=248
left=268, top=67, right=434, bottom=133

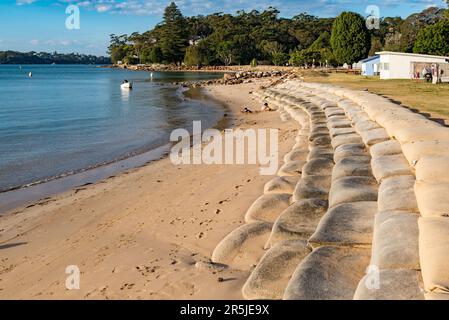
left=296, top=80, right=449, bottom=299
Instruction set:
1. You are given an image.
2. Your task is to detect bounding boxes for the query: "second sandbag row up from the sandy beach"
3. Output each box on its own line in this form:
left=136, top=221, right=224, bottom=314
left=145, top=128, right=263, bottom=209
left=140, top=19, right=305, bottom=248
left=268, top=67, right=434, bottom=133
left=242, top=86, right=333, bottom=299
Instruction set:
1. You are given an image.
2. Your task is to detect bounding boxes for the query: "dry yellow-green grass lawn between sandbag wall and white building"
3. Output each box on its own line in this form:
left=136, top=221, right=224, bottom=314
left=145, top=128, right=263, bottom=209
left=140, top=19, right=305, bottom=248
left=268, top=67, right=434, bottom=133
left=299, top=70, right=449, bottom=123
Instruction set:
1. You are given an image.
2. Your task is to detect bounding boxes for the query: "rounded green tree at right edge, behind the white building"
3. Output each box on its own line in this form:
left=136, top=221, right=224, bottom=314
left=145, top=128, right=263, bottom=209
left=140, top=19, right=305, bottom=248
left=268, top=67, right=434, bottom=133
left=413, top=20, right=449, bottom=56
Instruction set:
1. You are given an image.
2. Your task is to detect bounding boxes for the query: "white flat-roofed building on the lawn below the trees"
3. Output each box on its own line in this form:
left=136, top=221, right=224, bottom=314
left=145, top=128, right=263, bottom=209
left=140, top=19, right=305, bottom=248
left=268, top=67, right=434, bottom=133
left=376, top=51, right=449, bottom=79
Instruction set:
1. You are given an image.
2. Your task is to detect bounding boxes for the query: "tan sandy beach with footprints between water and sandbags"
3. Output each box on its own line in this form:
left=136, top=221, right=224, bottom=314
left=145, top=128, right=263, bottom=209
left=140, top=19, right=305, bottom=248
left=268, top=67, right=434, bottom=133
left=0, top=80, right=297, bottom=299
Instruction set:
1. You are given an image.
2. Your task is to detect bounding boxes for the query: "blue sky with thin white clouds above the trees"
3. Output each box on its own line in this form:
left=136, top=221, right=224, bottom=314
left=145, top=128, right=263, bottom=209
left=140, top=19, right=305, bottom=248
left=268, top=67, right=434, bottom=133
left=0, top=0, right=446, bottom=55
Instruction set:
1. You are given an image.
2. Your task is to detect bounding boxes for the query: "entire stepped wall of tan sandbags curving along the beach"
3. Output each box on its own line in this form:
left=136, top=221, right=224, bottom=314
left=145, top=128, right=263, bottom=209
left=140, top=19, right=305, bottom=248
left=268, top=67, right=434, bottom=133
left=212, top=80, right=449, bottom=299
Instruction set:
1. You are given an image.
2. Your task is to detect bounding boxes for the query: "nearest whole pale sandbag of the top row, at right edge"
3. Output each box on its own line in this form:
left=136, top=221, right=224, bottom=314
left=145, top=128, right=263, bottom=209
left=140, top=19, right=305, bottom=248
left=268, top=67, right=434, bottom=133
left=418, top=217, right=449, bottom=294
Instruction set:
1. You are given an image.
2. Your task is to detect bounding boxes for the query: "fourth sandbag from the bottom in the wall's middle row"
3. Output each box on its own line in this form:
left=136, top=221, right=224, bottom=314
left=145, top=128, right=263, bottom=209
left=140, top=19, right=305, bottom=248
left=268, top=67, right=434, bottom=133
left=332, top=156, right=372, bottom=180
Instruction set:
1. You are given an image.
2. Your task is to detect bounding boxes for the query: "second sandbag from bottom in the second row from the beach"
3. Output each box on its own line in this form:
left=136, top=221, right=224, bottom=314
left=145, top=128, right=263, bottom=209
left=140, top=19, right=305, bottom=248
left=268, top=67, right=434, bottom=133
left=267, top=199, right=327, bottom=247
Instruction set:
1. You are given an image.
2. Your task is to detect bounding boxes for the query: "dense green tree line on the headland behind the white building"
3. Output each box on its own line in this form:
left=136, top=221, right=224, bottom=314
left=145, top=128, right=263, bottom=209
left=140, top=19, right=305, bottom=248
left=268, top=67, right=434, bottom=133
left=108, top=2, right=449, bottom=67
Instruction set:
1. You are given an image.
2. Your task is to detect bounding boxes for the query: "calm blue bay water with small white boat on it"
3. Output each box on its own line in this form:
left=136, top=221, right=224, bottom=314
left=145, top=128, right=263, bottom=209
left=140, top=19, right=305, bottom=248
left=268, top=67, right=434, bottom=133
left=0, top=65, right=223, bottom=191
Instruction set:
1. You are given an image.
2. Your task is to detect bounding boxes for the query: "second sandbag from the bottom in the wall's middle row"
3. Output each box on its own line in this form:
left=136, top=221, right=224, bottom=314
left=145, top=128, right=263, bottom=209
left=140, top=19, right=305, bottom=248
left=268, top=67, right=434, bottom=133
left=309, top=201, right=377, bottom=248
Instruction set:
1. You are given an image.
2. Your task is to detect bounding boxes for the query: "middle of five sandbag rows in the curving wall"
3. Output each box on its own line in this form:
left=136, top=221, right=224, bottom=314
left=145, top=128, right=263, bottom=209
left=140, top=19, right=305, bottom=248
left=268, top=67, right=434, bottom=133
left=270, top=88, right=377, bottom=300
